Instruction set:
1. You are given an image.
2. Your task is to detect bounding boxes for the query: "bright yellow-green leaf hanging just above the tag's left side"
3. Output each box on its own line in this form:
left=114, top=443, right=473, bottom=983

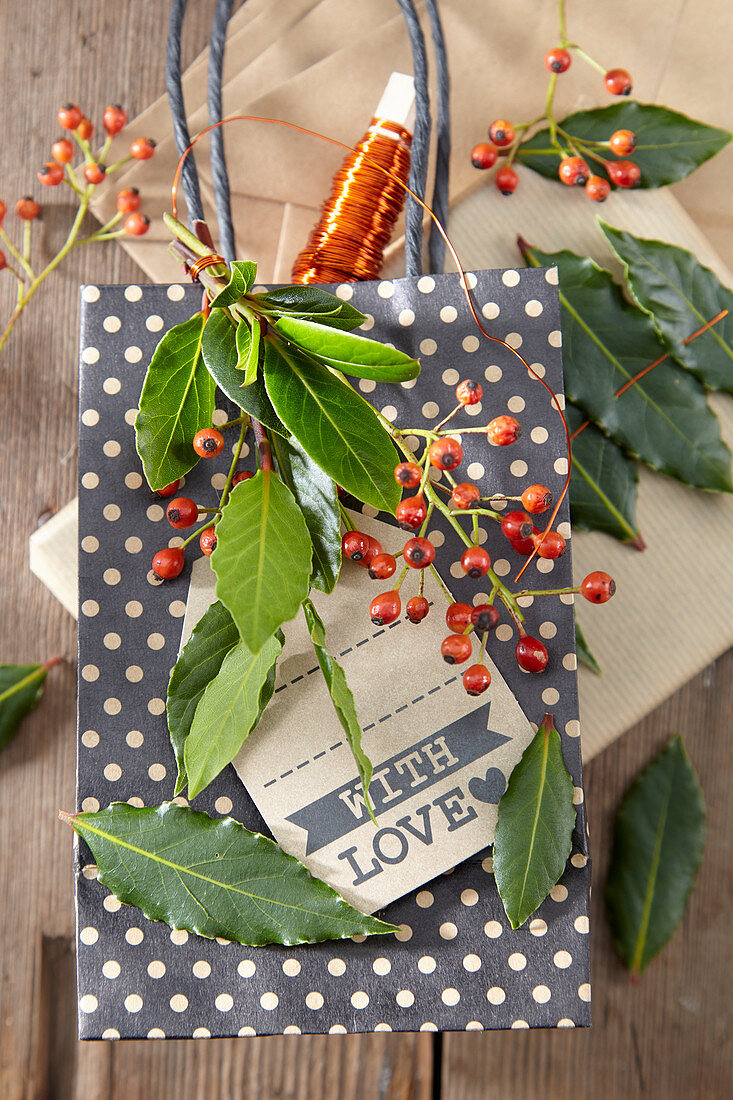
left=211, top=470, right=313, bottom=653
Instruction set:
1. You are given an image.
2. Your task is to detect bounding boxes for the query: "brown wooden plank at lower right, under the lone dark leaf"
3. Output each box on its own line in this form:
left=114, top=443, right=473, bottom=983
left=440, top=650, right=733, bottom=1100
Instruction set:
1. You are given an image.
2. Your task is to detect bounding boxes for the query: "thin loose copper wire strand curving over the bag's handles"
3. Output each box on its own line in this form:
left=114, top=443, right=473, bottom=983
left=171, top=114, right=572, bottom=582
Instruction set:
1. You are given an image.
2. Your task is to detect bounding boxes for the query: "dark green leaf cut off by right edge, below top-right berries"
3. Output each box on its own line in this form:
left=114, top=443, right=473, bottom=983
left=599, top=218, right=733, bottom=394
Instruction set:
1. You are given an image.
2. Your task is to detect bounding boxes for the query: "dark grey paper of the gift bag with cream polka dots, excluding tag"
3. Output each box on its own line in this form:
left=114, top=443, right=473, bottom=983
left=77, top=270, right=590, bottom=1038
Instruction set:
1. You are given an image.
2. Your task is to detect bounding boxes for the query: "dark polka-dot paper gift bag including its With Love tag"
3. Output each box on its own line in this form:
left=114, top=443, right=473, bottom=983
left=76, top=270, right=590, bottom=1038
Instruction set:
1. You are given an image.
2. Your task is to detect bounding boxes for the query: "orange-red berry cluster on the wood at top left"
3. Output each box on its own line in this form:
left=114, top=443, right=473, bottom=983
left=6, top=103, right=155, bottom=237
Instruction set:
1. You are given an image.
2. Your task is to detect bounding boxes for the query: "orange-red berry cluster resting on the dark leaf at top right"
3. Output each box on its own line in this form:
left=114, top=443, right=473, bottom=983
left=471, top=35, right=642, bottom=202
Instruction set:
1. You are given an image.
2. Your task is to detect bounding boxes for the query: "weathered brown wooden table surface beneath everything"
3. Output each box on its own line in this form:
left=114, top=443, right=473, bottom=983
left=0, top=0, right=733, bottom=1100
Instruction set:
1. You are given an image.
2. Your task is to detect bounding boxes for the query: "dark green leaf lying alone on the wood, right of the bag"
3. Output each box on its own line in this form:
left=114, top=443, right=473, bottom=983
left=605, top=737, right=705, bottom=975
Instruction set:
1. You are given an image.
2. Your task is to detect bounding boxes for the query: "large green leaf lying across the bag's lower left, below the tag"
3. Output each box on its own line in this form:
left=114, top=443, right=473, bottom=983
left=59, top=802, right=397, bottom=947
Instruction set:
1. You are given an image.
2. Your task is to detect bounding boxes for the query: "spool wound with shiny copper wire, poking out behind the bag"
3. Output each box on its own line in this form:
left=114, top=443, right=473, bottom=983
left=292, top=74, right=412, bottom=283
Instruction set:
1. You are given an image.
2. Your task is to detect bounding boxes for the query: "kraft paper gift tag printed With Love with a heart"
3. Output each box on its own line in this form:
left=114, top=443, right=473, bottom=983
left=176, top=515, right=534, bottom=912
